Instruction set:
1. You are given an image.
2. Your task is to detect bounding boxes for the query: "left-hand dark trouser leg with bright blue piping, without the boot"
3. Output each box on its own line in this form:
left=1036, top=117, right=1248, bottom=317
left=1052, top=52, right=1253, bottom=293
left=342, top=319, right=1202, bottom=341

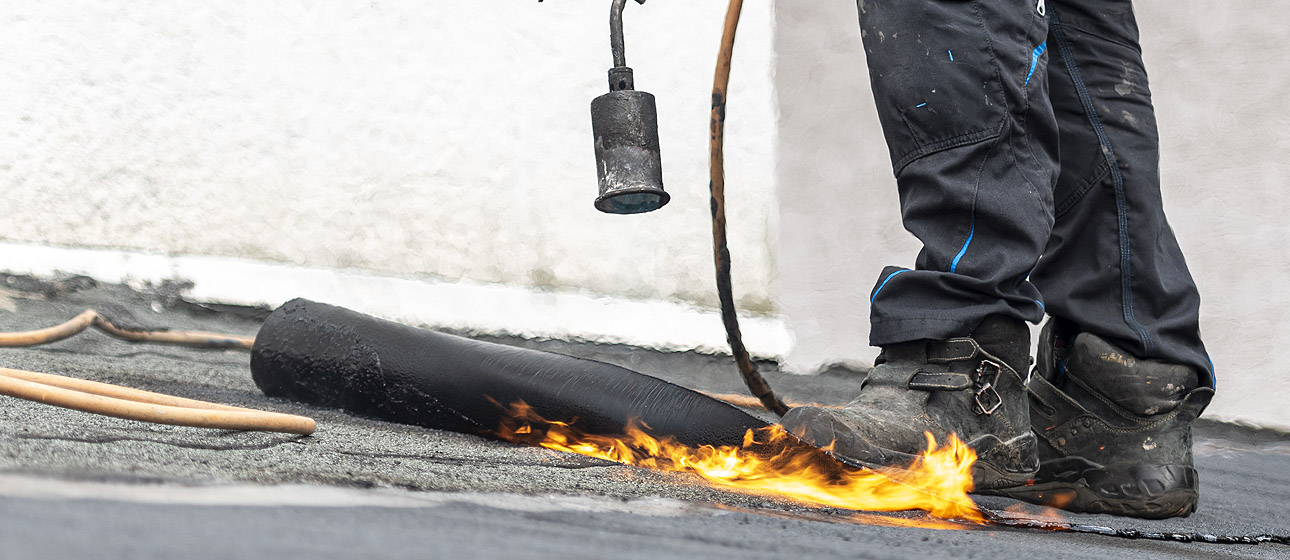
left=859, top=0, right=1057, bottom=346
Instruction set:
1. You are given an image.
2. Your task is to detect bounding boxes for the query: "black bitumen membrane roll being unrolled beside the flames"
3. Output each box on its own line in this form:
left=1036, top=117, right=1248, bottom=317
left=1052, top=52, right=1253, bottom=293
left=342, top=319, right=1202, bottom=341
left=250, top=299, right=766, bottom=445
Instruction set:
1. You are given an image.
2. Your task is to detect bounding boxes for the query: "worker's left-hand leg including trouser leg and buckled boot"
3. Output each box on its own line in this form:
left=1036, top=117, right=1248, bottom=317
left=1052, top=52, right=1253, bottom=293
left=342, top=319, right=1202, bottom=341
left=783, top=0, right=1057, bottom=488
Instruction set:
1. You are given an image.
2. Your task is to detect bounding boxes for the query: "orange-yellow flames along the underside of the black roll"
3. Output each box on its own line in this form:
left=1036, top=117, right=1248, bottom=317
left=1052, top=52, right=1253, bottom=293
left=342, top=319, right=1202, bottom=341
left=498, top=401, right=984, bottom=524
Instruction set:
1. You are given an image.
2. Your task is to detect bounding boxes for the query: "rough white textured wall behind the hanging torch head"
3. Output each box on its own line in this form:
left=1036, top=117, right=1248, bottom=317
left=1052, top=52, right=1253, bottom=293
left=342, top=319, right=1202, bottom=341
left=0, top=0, right=775, bottom=312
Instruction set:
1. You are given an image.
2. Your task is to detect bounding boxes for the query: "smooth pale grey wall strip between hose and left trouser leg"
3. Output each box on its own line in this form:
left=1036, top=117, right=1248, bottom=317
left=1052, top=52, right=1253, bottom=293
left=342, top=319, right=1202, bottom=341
left=775, top=0, right=920, bottom=372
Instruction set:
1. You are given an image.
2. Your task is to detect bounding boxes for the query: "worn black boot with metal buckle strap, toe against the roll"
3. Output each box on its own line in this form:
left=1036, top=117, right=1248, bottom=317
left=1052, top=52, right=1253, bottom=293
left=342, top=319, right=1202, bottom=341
left=782, top=316, right=1038, bottom=488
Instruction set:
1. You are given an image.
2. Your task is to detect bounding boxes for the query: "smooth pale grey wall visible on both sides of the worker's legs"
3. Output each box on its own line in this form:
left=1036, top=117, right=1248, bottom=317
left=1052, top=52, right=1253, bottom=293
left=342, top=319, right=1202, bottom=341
left=775, top=0, right=1290, bottom=428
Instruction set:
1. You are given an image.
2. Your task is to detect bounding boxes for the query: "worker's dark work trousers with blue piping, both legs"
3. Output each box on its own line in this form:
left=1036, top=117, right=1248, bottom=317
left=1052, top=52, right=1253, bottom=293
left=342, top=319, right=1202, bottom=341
left=858, top=0, right=1213, bottom=386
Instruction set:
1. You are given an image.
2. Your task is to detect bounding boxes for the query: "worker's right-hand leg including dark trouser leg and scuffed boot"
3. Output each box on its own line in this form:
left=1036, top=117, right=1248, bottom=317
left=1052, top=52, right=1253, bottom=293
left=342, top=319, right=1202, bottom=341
left=1001, top=0, right=1213, bottom=517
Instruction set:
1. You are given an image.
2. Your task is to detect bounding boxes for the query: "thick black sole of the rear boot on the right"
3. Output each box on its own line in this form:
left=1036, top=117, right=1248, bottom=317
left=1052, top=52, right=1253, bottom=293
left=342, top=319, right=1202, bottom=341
left=983, top=458, right=1200, bottom=519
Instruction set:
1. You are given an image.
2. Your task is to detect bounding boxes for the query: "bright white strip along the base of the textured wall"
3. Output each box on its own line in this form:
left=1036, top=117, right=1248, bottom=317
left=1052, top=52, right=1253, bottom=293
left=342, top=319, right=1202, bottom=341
left=0, top=241, right=806, bottom=363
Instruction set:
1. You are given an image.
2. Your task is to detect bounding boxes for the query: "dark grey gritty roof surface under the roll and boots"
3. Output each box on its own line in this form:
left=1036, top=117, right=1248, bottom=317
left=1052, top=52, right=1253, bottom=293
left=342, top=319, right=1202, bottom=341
left=0, top=276, right=1290, bottom=559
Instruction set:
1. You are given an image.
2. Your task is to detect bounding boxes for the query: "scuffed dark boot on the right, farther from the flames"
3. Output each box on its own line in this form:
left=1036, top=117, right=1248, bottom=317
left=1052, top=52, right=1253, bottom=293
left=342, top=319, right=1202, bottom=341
left=995, top=317, right=1214, bottom=519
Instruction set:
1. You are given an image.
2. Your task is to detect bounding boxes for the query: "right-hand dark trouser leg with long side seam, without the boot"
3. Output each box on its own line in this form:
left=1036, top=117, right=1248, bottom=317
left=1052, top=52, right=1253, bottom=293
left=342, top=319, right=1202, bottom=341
left=1031, top=0, right=1213, bottom=386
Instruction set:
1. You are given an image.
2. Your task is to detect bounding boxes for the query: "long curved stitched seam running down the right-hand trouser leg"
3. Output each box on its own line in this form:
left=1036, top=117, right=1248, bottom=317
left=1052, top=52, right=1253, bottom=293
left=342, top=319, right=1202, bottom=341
left=1050, top=14, right=1155, bottom=354
